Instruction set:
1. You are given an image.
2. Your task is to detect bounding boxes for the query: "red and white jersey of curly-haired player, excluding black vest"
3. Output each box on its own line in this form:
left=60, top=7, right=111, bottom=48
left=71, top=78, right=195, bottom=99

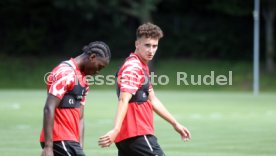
left=115, top=53, right=154, bottom=142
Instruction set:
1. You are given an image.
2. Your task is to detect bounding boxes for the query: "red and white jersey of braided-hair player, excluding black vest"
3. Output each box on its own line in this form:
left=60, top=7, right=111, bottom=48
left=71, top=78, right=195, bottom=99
left=40, top=58, right=89, bottom=142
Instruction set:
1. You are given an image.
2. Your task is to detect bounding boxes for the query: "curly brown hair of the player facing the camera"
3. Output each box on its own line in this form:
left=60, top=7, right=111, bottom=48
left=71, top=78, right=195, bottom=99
left=136, top=22, right=163, bottom=39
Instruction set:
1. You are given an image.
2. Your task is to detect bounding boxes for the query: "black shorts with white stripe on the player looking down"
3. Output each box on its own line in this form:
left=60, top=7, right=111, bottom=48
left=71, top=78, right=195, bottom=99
left=40, top=141, right=85, bottom=156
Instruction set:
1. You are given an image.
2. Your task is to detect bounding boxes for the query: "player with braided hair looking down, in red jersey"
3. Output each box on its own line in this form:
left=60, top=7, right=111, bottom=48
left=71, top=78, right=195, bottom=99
left=40, top=41, right=111, bottom=156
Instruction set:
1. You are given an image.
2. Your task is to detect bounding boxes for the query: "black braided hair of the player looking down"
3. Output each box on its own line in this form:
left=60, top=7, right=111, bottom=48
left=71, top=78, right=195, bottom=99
left=82, top=41, right=111, bottom=60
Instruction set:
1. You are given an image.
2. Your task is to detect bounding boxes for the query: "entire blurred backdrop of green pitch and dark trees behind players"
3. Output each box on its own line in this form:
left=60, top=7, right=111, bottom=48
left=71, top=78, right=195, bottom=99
left=0, top=0, right=276, bottom=156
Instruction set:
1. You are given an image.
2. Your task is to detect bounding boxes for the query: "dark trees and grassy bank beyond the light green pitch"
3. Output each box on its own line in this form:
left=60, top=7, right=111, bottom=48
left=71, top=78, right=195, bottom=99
left=0, top=0, right=276, bottom=91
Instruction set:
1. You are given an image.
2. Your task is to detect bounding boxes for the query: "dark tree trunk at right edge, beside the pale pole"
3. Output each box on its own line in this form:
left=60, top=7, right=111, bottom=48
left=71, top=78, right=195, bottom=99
left=263, top=0, right=276, bottom=73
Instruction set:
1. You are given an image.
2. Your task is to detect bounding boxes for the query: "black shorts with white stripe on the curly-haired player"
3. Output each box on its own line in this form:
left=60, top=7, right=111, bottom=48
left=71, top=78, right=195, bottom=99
left=116, top=135, right=165, bottom=156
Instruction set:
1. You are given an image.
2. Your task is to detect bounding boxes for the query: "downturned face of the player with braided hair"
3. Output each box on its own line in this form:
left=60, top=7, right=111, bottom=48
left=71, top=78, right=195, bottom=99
left=84, top=54, right=109, bottom=75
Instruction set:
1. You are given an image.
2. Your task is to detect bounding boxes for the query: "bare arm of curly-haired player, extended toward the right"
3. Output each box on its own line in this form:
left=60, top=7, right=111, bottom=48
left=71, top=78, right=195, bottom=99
left=149, top=90, right=191, bottom=141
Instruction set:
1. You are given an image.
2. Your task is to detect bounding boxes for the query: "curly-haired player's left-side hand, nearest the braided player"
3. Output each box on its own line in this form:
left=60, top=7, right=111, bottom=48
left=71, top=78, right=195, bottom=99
left=98, top=130, right=118, bottom=148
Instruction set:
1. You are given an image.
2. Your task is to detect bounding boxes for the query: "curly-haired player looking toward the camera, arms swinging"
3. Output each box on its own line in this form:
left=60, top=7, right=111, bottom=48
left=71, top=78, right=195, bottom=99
left=98, top=23, right=191, bottom=156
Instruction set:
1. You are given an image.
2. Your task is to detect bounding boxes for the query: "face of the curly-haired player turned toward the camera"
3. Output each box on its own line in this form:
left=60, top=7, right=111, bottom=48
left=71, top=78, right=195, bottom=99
left=135, top=37, right=159, bottom=63
